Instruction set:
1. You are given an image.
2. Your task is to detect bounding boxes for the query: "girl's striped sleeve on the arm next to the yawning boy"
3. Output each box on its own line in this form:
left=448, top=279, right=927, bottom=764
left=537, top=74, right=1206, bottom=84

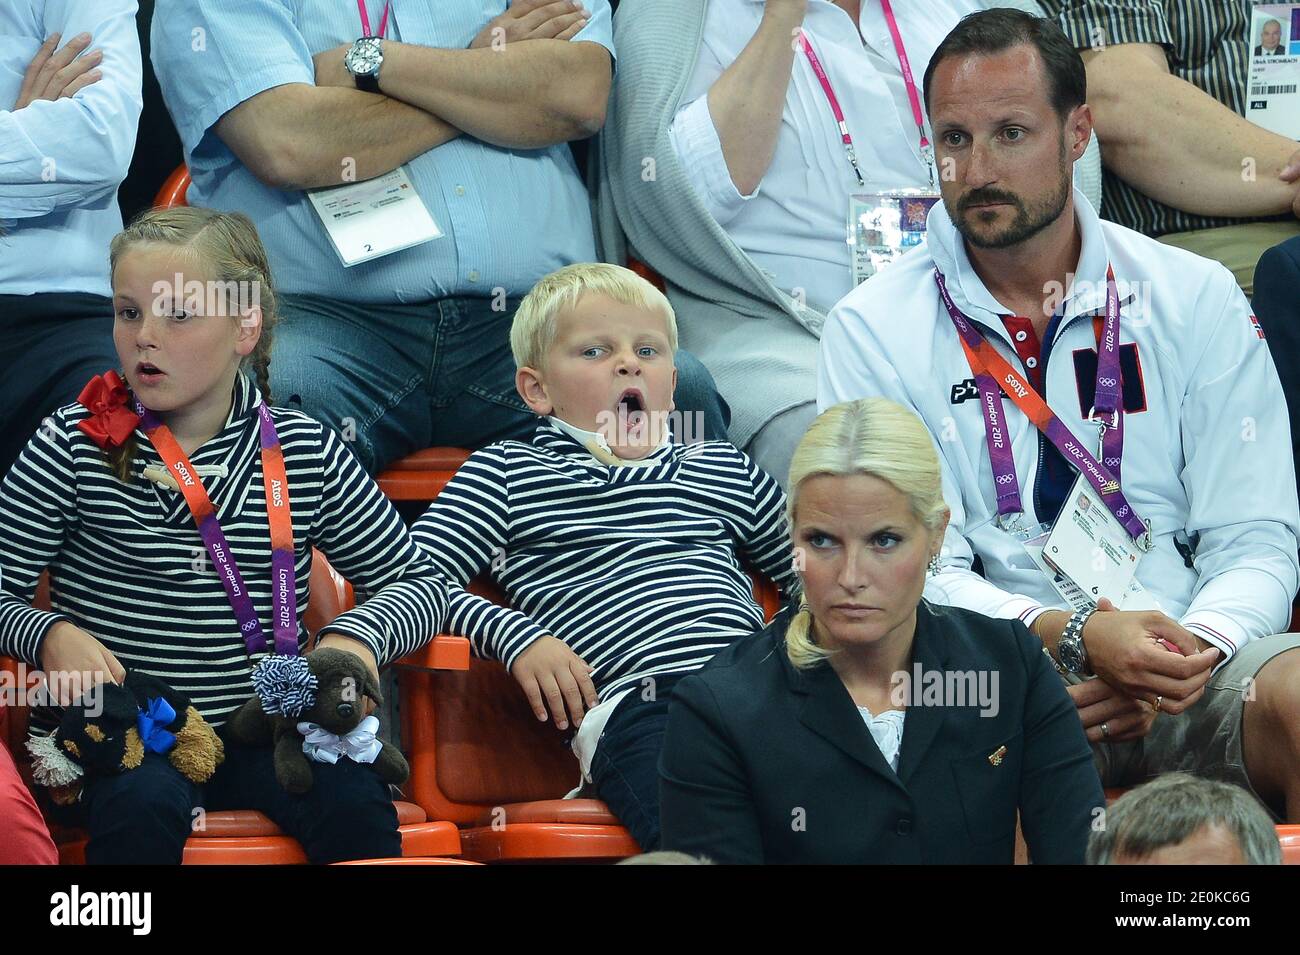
left=313, top=426, right=447, bottom=665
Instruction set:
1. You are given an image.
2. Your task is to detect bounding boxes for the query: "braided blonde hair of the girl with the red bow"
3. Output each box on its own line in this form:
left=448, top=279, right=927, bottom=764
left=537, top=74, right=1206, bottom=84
left=105, top=205, right=278, bottom=482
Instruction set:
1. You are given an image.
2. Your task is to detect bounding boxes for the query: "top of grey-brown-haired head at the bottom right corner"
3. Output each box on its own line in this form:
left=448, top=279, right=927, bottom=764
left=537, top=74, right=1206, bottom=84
left=1087, top=773, right=1282, bottom=865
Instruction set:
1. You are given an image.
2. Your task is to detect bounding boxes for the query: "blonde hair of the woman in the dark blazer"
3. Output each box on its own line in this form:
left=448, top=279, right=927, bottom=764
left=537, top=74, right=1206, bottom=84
left=785, top=398, right=948, bottom=669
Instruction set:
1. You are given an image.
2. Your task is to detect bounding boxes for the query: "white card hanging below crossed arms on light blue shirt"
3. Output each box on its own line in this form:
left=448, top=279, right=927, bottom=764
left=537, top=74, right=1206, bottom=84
left=307, top=166, right=442, bottom=268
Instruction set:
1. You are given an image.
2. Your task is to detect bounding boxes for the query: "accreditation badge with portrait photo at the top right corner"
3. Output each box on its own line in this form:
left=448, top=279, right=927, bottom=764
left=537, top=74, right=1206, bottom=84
left=1245, top=4, right=1300, bottom=139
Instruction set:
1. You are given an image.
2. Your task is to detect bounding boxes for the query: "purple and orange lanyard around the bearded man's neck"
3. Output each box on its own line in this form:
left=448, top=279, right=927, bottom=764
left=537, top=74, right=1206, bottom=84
left=935, top=268, right=1151, bottom=551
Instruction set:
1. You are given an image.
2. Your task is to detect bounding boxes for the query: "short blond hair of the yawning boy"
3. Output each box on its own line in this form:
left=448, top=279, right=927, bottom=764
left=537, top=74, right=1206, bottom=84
left=510, top=262, right=677, bottom=368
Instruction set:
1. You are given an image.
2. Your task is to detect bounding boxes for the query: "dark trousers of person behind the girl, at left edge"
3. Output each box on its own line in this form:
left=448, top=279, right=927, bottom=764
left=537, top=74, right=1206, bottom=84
left=0, top=292, right=121, bottom=478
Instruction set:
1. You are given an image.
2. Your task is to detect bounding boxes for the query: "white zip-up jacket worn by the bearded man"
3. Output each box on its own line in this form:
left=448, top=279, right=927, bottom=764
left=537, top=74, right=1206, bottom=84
left=818, top=191, right=1300, bottom=660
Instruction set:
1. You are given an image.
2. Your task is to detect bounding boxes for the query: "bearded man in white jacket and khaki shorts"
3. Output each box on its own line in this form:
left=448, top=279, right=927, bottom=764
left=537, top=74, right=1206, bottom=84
left=818, top=10, right=1300, bottom=821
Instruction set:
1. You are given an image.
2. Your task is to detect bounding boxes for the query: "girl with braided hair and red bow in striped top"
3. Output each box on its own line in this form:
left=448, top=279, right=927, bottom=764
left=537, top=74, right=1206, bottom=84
left=0, top=208, right=447, bottom=863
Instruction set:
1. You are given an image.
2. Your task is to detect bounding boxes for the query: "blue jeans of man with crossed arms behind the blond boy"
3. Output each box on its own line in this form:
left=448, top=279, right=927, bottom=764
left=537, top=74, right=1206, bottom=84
left=270, top=295, right=731, bottom=474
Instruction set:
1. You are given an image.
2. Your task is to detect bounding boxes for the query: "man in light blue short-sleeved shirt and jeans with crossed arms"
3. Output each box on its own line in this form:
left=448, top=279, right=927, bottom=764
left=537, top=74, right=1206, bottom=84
left=152, top=0, right=727, bottom=473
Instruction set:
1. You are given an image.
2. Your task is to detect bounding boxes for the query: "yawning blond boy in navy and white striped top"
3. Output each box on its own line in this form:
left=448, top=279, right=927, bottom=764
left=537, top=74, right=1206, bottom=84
left=412, top=264, right=797, bottom=851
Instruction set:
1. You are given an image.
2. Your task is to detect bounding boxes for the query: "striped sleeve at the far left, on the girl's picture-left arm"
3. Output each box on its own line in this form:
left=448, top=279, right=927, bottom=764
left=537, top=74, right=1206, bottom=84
left=0, top=412, right=77, bottom=667
